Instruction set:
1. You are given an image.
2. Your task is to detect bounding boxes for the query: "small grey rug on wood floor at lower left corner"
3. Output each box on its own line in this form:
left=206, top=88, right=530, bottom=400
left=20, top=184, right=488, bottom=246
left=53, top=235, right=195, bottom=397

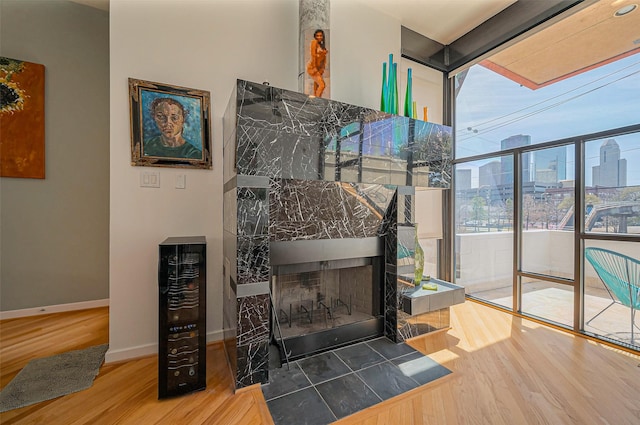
left=0, top=344, right=109, bottom=412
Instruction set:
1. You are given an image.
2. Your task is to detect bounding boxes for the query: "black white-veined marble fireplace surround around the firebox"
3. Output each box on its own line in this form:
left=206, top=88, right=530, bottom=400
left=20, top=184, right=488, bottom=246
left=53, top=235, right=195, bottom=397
left=223, top=80, right=451, bottom=389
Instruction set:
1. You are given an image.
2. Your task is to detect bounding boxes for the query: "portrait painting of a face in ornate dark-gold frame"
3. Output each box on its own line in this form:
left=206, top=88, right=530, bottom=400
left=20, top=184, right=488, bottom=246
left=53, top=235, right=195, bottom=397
left=129, top=78, right=211, bottom=169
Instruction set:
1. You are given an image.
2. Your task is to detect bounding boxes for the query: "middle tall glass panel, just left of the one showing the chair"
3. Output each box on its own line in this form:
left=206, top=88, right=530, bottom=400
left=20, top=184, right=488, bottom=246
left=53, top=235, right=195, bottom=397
left=518, top=145, right=575, bottom=327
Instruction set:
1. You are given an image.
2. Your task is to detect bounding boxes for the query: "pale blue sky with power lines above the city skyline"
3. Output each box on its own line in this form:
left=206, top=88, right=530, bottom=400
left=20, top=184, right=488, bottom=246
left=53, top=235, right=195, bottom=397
left=455, top=54, right=640, bottom=185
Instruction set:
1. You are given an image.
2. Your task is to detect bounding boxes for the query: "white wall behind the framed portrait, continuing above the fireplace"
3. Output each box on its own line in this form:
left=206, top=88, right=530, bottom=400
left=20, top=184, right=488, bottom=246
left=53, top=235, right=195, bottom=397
left=106, top=0, right=444, bottom=362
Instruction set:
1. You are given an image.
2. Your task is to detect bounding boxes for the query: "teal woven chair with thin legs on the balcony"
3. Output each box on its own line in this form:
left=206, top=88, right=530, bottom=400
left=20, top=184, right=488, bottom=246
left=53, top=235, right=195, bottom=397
left=584, top=247, right=640, bottom=344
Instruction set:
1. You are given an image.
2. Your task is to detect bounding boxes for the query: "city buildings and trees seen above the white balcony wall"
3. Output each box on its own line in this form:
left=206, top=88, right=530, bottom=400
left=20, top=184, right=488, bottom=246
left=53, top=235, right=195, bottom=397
left=455, top=135, right=640, bottom=233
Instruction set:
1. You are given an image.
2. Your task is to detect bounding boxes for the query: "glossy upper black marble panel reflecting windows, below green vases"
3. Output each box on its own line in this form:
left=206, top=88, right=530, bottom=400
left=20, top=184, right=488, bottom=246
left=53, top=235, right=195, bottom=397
left=236, top=81, right=451, bottom=188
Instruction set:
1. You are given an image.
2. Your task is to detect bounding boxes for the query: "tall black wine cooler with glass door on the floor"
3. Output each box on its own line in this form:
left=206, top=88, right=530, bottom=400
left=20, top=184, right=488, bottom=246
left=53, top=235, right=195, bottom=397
left=158, top=236, right=207, bottom=398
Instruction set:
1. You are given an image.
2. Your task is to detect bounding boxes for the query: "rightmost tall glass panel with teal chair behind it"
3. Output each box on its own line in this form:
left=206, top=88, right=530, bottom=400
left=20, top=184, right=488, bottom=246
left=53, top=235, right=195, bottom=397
left=582, top=132, right=640, bottom=348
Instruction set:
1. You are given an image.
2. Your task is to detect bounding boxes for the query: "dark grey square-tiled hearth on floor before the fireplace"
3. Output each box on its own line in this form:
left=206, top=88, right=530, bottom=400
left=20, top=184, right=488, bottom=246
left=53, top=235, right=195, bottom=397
left=262, top=337, right=451, bottom=425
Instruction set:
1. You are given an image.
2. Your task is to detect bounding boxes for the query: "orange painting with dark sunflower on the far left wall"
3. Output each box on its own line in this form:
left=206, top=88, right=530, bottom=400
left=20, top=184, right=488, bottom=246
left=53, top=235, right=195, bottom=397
left=0, top=57, right=44, bottom=179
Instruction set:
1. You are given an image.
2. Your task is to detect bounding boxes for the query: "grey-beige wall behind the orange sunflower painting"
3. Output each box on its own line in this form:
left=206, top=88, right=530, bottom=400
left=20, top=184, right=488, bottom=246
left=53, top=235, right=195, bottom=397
left=0, top=0, right=109, bottom=318
